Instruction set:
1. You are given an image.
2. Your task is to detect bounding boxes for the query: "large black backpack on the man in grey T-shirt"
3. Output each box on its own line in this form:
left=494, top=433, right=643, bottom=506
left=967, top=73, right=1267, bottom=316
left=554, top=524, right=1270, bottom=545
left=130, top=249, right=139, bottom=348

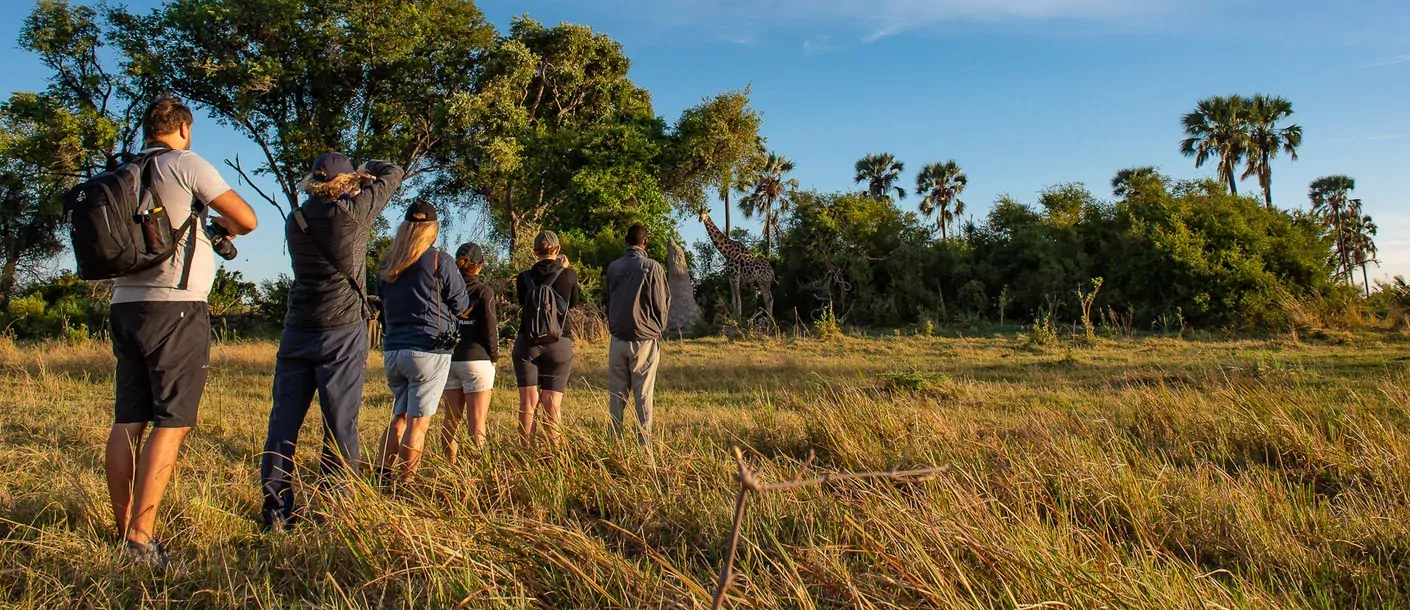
left=63, top=148, right=204, bottom=290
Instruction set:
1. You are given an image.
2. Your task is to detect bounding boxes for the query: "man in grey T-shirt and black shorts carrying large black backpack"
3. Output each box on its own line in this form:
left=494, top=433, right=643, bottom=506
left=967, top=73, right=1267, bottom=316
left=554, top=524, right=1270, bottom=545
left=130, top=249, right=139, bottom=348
left=93, top=97, right=257, bottom=566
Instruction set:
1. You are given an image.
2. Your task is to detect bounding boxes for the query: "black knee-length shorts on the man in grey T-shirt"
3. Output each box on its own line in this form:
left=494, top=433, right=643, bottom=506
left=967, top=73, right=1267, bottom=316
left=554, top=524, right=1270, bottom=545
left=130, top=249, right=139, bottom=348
left=109, top=301, right=210, bottom=428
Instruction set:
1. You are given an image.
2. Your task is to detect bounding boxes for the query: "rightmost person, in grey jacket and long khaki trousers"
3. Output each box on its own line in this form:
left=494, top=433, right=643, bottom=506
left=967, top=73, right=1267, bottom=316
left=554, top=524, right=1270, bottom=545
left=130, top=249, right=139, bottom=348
left=606, top=224, right=671, bottom=449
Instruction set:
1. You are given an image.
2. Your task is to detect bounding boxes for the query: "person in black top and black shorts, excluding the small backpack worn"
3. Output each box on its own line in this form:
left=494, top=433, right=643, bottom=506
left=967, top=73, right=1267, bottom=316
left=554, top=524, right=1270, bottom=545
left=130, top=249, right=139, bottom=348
left=513, top=231, right=581, bottom=444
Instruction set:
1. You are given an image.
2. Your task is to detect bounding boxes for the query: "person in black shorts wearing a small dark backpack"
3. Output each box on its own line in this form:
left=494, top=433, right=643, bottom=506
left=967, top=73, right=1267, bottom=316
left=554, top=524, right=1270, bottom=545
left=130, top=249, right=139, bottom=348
left=513, top=231, right=580, bottom=444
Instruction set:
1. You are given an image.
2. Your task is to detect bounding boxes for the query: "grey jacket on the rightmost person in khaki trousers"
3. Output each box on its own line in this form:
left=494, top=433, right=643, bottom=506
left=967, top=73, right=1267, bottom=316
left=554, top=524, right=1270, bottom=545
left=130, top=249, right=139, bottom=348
left=606, top=247, right=671, bottom=341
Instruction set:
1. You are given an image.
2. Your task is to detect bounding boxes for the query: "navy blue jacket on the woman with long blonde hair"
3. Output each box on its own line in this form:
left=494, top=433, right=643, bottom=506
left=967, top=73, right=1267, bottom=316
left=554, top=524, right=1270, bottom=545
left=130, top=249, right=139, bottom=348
left=378, top=248, right=470, bottom=352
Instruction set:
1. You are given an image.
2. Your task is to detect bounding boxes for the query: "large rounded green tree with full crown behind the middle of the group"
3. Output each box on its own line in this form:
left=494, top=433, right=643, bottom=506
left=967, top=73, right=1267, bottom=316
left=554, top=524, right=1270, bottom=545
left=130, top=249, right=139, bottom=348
left=434, top=17, right=673, bottom=252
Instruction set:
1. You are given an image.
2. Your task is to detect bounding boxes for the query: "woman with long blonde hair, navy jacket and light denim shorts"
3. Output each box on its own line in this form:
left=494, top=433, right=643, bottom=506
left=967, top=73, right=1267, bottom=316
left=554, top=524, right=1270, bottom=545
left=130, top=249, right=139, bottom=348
left=378, top=201, right=470, bottom=482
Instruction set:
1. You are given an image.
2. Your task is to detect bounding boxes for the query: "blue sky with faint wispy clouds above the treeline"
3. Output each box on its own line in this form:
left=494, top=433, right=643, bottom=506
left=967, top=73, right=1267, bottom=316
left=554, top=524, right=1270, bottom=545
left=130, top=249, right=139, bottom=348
left=0, top=0, right=1410, bottom=284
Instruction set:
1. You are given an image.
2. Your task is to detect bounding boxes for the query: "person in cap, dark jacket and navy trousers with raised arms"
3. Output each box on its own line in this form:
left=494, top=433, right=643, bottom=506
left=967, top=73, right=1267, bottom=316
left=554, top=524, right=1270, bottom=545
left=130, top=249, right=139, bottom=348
left=259, top=152, right=403, bottom=527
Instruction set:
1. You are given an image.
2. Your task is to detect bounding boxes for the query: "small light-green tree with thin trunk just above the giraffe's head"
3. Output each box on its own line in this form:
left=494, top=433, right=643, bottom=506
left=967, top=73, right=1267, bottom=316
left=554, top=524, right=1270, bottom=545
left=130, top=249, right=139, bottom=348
left=668, top=87, right=764, bottom=234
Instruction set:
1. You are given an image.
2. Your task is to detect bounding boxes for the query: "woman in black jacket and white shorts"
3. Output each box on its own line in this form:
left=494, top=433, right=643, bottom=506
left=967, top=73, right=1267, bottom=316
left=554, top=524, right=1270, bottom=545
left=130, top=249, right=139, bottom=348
left=441, top=244, right=499, bottom=463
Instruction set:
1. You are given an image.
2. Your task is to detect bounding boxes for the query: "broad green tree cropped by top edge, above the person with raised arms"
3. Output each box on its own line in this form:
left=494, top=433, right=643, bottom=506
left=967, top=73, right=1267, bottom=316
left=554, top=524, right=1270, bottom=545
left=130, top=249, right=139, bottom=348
left=114, top=0, right=495, bottom=213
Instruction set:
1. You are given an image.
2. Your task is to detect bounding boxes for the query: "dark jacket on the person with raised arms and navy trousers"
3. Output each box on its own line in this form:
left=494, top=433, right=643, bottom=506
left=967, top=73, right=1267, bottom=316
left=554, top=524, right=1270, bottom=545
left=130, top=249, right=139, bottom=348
left=283, top=161, right=405, bottom=331
